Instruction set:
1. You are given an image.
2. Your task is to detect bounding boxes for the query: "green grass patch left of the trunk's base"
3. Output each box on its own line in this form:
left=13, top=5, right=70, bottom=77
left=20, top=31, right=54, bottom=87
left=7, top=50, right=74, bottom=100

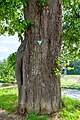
left=0, top=89, right=17, bottom=113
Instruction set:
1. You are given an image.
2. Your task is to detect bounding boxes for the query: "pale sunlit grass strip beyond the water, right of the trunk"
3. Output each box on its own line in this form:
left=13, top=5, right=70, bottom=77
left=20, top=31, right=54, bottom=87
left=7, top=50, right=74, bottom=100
left=61, top=75, right=80, bottom=89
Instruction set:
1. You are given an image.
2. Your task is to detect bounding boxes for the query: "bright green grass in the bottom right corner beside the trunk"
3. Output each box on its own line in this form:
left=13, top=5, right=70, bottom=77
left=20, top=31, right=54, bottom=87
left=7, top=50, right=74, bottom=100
left=60, top=97, right=80, bottom=120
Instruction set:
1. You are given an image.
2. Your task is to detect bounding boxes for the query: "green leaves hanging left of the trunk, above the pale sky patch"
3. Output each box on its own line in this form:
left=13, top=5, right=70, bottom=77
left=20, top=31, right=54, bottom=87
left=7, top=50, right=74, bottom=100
left=0, top=0, right=33, bottom=38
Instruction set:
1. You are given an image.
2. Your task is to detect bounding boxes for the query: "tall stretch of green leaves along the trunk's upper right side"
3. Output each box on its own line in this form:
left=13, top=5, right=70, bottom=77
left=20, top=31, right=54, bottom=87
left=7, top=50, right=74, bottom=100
left=62, top=0, right=80, bottom=60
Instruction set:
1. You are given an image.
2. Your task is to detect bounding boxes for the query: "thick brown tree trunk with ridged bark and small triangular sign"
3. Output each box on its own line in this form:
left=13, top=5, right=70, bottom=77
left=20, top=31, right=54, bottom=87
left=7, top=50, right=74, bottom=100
left=16, top=0, right=61, bottom=114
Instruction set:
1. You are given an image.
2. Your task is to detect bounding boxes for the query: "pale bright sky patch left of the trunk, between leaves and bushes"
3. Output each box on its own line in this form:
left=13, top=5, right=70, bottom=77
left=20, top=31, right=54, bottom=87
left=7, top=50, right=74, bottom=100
left=0, top=34, right=20, bottom=60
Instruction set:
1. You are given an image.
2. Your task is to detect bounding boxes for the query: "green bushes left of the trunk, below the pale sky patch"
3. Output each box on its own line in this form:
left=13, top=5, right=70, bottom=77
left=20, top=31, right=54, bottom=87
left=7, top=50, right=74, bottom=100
left=0, top=53, right=16, bottom=83
